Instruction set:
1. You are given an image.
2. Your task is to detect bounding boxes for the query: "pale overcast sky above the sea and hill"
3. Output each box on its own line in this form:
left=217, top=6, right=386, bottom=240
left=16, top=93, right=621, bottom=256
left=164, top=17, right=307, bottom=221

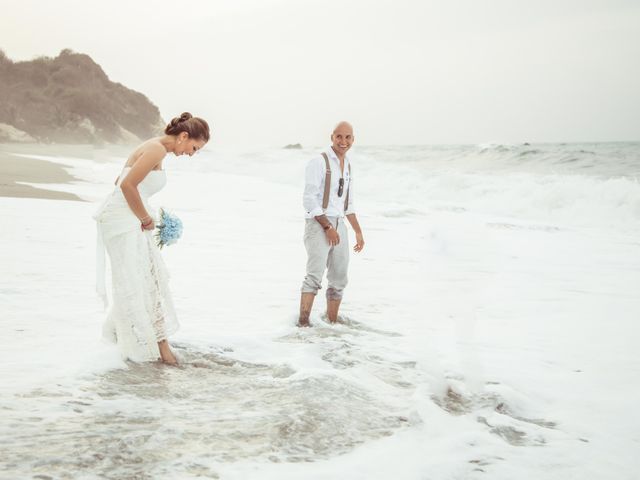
left=0, top=0, right=640, bottom=146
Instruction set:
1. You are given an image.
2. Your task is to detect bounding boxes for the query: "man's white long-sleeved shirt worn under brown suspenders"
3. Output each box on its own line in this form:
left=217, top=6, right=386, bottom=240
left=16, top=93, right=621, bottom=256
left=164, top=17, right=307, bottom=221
left=302, top=147, right=356, bottom=218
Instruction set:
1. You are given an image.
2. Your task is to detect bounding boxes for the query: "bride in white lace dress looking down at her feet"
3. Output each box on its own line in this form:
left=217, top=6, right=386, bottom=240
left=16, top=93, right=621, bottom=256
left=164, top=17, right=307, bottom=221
left=94, top=113, right=209, bottom=365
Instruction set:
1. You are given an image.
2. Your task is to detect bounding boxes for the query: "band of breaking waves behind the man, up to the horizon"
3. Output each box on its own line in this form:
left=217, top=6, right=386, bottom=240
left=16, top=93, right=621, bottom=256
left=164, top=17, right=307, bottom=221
left=180, top=143, right=640, bottom=228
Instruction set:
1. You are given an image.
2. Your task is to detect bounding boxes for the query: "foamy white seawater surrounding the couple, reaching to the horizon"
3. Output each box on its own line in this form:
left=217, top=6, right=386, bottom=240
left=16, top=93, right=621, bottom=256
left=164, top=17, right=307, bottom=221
left=0, top=146, right=640, bottom=480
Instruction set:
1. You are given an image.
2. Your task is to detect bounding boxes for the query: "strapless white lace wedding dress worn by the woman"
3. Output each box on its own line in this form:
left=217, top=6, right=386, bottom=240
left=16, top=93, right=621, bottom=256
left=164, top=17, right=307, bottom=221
left=94, top=167, right=178, bottom=362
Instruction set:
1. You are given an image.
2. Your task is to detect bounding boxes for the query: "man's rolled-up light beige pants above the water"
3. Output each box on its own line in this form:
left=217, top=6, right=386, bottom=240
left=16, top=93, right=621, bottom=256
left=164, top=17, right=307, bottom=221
left=302, top=217, right=349, bottom=300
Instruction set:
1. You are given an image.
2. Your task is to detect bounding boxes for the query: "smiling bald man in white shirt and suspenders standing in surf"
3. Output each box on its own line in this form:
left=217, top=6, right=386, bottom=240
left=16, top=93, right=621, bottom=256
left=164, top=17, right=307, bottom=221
left=298, top=122, right=364, bottom=327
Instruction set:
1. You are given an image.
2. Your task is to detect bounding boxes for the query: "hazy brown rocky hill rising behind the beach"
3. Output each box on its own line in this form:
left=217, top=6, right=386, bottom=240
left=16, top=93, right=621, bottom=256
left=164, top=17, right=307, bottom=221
left=0, top=49, right=164, bottom=144
